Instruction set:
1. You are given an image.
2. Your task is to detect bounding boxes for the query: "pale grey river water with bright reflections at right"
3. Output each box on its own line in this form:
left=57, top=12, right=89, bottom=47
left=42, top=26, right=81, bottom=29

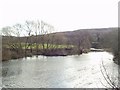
left=2, top=52, right=118, bottom=88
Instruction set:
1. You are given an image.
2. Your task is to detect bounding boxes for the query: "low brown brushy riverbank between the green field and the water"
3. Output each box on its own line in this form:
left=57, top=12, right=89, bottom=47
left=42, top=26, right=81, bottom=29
left=2, top=48, right=89, bottom=61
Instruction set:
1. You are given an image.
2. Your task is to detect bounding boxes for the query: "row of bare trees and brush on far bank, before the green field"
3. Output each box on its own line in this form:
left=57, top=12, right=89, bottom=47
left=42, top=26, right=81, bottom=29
left=2, top=21, right=91, bottom=60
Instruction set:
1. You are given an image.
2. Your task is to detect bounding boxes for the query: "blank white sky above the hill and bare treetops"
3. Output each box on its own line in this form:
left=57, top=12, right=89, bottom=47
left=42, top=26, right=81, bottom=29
left=0, top=0, right=119, bottom=31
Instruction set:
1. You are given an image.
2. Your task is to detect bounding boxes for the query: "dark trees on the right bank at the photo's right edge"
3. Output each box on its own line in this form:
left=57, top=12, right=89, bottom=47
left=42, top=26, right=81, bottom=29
left=101, top=28, right=120, bottom=65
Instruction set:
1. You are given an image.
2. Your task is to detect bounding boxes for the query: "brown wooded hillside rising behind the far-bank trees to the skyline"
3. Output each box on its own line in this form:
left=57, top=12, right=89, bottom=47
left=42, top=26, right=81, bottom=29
left=2, top=28, right=118, bottom=47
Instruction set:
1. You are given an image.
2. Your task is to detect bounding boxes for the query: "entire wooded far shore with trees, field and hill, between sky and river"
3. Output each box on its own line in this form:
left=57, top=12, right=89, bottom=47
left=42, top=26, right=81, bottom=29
left=1, top=21, right=119, bottom=61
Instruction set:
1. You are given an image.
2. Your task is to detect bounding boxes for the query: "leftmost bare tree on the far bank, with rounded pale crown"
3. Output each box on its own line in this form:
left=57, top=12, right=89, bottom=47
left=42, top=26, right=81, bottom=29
left=2, top=24, right=22, bottom=52
